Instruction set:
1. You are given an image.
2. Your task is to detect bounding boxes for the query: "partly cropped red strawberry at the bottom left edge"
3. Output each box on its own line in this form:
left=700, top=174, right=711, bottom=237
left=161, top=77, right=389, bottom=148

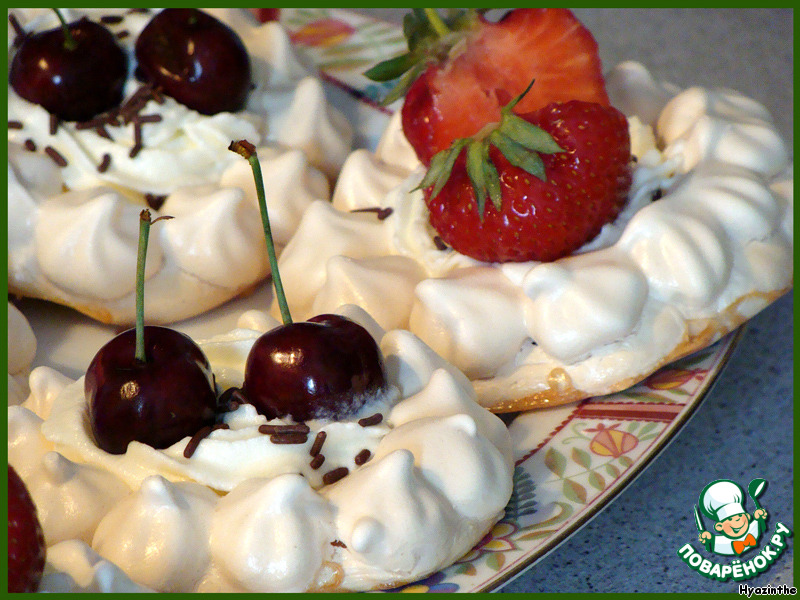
left=8, top=465, right=45, bottom=592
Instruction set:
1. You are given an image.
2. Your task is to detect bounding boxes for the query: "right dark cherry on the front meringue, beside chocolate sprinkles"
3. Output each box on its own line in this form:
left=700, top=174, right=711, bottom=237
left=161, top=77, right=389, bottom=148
left=244, top=315, right=386, bottom=421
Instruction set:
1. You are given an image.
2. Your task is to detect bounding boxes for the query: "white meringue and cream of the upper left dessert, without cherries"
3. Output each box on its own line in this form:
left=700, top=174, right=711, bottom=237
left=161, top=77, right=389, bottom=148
left=8, top=9, right=353, bottom=324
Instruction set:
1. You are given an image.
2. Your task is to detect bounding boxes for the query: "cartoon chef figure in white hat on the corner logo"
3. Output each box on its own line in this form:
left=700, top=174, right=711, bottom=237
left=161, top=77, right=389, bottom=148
left=694, top=479, right=767, bottom=556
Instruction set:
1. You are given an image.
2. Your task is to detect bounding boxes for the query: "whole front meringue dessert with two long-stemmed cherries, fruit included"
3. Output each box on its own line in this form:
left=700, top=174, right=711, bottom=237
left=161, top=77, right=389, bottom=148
left=8, top=141, right=514, bottom=592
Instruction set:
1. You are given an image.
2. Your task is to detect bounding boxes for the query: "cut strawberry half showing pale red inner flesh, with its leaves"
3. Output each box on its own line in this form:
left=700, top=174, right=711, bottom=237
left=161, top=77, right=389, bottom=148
left=366, top=8, right=608, bottom=165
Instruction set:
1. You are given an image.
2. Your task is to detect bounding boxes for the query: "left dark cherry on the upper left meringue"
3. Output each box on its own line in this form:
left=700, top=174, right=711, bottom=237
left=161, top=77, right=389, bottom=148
left=8, top=17, right=128, bottom=121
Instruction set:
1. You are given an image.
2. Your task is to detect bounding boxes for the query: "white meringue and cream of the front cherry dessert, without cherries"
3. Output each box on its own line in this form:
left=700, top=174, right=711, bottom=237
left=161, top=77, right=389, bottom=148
left=8, top=306, right=513, bottom=592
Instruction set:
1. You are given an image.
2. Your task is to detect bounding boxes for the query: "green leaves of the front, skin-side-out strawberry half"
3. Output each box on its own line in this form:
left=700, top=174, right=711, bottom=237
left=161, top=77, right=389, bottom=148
left=417, top=82, right=564, bottom=217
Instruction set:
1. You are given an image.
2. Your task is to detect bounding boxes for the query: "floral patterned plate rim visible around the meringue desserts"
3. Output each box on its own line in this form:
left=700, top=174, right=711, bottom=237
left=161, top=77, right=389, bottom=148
left=281, top=8, right=742, bottom=592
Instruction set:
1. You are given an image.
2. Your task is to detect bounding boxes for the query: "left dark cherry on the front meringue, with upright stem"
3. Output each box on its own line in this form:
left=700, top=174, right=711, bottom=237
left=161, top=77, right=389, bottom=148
left=84, top=326, right=217, bottom=454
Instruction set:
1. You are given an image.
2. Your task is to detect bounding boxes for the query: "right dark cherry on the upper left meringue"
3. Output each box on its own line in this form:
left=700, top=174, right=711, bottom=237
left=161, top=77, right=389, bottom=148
left=136, top=8, right=251, bottom=115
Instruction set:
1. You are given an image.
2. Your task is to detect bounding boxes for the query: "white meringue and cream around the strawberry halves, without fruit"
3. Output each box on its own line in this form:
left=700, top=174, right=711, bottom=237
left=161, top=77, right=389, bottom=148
left=272, top=63, right=793, bottom=407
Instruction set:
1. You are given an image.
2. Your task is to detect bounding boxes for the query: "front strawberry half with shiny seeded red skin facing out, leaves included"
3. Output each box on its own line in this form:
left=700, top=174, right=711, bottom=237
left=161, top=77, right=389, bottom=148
left=420, top=94, right=631, bottom=262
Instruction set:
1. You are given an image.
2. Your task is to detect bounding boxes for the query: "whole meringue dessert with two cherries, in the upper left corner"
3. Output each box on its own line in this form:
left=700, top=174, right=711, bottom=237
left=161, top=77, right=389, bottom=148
left=8, top=9, right=353, bottom=324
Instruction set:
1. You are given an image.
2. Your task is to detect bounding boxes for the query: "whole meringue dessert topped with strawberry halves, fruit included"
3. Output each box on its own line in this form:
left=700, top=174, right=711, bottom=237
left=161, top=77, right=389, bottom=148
left=279, top=9, right=793, bottom=412
